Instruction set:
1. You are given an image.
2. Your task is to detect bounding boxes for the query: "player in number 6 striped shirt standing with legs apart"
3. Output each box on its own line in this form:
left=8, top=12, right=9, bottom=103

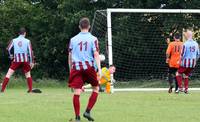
left=1, top=28, right=34, bottom=93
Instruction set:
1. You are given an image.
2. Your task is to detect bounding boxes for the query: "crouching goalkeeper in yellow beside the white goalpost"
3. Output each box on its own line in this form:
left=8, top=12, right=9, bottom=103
left=83, top=65, right=116, bottom=93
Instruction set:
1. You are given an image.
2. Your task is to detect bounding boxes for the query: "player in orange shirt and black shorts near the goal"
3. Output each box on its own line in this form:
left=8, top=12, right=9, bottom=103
left=166, top=33, right=183, bottom=93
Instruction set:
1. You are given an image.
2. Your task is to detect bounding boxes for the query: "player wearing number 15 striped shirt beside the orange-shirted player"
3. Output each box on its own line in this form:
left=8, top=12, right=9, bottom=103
left=176, top=30, right=199, bottom=94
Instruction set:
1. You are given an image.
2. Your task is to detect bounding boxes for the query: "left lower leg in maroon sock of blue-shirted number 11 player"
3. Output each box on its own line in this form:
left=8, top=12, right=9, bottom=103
left=73, top=89, right=82, bottom=122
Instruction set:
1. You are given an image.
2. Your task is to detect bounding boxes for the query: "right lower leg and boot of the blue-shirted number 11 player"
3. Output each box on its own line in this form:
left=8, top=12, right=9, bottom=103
left=83, top=86, right=99, bottom=121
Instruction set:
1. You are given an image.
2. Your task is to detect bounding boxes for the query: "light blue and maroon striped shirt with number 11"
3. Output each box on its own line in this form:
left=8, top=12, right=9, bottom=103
left=69, top=32, right=99, bottom=70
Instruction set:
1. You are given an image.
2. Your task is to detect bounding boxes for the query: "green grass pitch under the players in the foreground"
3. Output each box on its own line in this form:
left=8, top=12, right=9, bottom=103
left=0, top=88, right=200, bottom=122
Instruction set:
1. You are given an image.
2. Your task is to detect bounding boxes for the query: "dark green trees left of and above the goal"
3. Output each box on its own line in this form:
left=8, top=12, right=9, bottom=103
left=0, top=0, right=200, bottom=79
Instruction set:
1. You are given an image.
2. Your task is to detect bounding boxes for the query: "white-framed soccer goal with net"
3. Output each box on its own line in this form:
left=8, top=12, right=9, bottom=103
left=91, top=9, right=200, bottom=92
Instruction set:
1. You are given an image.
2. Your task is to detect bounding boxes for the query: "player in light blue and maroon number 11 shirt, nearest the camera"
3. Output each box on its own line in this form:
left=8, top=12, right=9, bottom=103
left=68, top=18, right=101, bottom=122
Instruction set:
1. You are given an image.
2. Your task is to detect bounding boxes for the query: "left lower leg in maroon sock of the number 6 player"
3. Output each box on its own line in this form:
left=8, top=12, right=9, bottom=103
left=1, top=68, right=15, bottom=92
